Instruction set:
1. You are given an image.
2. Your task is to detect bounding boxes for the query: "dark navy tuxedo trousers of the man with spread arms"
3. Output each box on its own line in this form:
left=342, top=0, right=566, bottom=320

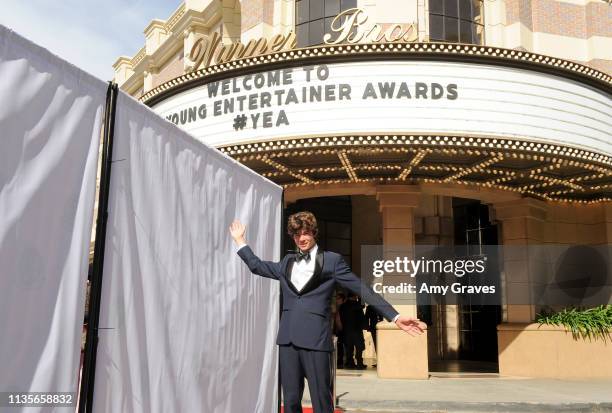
left=279, top=344, right=334, bottom=413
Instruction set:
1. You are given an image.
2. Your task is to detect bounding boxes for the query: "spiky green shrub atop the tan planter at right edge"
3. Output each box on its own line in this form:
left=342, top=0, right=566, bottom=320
left=536, top=305, right=612, bottom=341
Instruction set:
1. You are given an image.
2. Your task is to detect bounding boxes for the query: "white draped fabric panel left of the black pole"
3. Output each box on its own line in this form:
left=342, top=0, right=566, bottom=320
left=0, top=26, right=107, bottom=412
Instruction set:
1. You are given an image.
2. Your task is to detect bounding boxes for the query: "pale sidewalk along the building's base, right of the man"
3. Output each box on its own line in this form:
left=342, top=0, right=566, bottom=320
left=304, top=368, right=612, bottom=413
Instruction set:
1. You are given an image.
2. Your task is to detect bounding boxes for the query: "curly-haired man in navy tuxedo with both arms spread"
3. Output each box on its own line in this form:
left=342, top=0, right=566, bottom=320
left=230, top=212, right=425, bottom=413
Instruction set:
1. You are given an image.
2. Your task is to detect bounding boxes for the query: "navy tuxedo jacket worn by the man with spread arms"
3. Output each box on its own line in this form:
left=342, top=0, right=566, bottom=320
left=238, top=245, right=398, bottom=351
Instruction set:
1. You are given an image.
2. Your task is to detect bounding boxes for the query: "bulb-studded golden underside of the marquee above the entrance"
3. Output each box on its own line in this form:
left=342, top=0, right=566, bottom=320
left=219, top=135, right=612, bottom=202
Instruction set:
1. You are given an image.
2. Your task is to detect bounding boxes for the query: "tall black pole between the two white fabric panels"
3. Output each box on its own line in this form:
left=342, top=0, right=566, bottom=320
left=79, top=82, right=119, bottom=413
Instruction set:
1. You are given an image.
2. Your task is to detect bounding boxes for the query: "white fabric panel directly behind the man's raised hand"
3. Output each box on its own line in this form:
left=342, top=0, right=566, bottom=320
left=94, top=93, right=282, bottom=413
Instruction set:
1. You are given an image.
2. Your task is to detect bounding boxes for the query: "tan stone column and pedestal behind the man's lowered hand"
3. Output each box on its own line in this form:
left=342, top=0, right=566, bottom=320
left=376, top=185, right=429, bottom=379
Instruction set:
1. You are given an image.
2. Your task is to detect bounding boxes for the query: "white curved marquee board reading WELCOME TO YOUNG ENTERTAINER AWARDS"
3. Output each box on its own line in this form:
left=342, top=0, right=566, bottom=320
left=153, top=57, right=612, bottom=153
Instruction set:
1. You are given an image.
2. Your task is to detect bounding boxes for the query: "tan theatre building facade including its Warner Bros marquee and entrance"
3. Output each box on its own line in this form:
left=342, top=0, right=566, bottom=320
left=114, top=0, right=612, bottom=378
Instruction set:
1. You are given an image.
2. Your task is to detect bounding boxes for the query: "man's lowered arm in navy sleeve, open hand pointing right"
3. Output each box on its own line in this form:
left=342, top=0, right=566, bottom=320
left=335, top=253, right=427, bottom=335
